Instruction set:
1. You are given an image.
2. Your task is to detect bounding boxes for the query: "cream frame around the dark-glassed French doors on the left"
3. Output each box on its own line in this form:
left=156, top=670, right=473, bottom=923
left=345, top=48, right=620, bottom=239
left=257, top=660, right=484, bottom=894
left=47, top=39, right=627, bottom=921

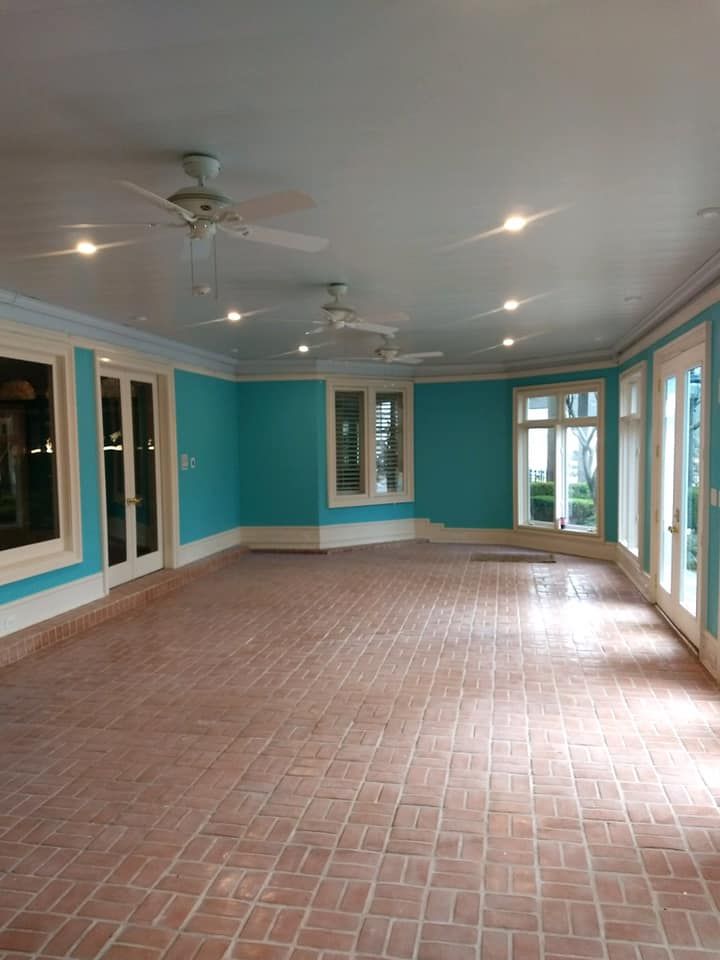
left=95, top=348, right=180, bottom=594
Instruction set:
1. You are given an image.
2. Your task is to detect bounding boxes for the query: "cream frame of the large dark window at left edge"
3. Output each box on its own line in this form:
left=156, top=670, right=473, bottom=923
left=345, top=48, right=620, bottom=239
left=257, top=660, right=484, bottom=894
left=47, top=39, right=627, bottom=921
left=0, top=321, right=83, bottom=584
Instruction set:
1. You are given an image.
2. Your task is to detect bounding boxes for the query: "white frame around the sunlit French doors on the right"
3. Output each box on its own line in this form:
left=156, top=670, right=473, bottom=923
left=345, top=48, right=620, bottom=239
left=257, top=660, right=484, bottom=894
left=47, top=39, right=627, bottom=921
left=650, top=321, right=713, bottom=647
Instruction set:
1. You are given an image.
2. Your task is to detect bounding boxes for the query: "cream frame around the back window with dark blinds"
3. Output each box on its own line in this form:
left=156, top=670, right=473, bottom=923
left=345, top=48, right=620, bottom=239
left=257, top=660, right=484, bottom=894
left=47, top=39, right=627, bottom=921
left=325, top=379, right=415, bottom=507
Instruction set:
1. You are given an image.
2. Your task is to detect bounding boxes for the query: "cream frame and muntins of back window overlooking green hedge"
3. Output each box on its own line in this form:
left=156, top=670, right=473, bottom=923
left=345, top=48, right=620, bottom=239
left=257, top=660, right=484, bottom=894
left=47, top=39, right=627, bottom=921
left=513, top=380, right=605, bottom=541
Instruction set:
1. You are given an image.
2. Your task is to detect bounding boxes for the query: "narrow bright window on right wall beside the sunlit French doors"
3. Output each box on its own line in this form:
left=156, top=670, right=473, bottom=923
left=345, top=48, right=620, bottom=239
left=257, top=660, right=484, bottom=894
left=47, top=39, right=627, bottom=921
left=618, top=366, right=645, bottom=557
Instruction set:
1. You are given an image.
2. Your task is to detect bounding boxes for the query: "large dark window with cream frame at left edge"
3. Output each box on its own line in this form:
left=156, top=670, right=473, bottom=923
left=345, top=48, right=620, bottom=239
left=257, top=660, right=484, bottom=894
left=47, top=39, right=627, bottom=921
left=0, top=329, right=82, bottom=583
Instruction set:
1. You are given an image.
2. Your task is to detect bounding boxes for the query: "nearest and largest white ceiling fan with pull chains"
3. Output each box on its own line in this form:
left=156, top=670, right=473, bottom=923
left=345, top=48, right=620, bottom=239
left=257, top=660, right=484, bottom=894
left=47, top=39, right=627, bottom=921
left=64, top=153, right=328, bottom=253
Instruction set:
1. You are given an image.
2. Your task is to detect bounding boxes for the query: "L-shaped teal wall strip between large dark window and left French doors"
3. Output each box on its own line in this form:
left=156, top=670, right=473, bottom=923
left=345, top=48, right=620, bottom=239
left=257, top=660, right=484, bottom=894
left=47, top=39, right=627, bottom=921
left=0, top=348, right=102, bottom=604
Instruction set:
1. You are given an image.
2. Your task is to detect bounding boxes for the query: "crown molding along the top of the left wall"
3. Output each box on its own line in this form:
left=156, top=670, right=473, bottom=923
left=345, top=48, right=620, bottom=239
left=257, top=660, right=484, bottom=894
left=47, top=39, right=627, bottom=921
left=0, top=289, right=237, bottom=376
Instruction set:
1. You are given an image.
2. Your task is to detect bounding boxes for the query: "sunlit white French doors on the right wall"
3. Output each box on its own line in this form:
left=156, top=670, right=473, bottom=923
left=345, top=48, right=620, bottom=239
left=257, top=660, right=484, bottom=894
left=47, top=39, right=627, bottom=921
left=655, top=344, right=705, bottom=646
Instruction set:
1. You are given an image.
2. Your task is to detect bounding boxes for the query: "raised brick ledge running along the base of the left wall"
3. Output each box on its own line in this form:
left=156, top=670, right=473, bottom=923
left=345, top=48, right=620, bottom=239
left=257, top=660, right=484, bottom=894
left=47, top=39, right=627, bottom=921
left=0, top=547, right=247, bottom=667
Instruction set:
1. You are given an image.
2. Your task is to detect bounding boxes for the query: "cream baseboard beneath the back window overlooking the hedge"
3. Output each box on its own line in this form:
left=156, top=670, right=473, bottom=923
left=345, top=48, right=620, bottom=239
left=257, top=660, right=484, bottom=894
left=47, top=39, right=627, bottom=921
left=415, top=520, right=615, bottom=560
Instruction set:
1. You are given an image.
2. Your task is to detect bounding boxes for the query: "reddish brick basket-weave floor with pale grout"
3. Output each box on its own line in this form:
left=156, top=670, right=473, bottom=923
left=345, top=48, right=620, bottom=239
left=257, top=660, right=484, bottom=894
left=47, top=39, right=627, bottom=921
left=0, top=544, right=720, bottom=960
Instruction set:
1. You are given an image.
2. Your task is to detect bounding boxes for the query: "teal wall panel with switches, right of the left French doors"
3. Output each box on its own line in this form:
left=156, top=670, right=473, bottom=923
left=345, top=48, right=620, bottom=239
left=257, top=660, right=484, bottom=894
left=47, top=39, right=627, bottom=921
left=175, top=370, right=243, bottom=543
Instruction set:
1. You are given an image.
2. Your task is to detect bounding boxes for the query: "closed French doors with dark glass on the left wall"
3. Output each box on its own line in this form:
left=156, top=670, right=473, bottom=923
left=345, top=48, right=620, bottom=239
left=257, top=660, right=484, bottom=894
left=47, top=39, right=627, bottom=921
left=100, top=370, right=163, bottom=587
